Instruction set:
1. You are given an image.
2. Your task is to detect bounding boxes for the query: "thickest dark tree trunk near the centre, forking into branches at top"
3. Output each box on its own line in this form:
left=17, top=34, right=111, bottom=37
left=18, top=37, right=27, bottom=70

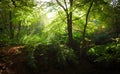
left=56, top=0, right=73, bottom=47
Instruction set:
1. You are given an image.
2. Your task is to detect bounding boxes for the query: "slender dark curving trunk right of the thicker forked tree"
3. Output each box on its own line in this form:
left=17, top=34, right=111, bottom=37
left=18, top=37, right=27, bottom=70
left=80, top=0, right=94, bottom=57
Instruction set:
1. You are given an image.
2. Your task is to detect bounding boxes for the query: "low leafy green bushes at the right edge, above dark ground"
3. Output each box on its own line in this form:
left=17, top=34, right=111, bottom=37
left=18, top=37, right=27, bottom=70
left=88, top=38, right=120, bottom=64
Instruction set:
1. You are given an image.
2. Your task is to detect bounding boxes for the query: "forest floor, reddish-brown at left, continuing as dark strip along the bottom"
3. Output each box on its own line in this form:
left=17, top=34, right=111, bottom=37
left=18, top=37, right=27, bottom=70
left=0, top=46, right=120, bottom=74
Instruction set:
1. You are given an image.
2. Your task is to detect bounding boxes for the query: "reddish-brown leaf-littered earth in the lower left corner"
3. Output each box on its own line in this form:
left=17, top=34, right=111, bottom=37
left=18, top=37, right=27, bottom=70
left=0, top=46, right=30, bottom=74
